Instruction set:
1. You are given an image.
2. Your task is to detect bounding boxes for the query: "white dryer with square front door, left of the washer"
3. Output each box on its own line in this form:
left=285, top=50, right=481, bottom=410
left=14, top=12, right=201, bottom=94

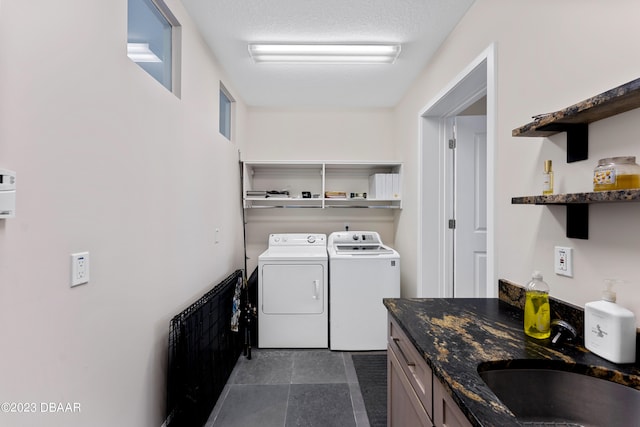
left=258, top=234, right=329, bottom=348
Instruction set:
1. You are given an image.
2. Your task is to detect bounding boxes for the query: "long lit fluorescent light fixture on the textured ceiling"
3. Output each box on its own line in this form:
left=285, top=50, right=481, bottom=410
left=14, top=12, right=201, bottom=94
left=249, top=43, right=400, bottom=64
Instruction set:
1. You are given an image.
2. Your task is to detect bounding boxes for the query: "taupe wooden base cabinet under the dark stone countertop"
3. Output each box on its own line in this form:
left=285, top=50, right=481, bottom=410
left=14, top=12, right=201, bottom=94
left=387, top=316, right=471, bottom=427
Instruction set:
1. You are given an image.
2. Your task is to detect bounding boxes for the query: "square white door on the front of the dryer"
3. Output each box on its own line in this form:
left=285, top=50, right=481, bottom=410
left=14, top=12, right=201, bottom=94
left=262, top=264, right=325, bottom=314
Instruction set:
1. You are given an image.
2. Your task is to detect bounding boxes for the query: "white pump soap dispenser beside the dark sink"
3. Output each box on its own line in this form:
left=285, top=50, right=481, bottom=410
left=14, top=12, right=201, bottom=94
left=584, top=280, right=636, bottom=363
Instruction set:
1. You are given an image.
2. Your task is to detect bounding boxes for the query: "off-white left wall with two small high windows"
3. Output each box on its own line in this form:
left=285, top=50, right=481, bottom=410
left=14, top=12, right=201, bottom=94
left=0, top=0, right=246, bottom=427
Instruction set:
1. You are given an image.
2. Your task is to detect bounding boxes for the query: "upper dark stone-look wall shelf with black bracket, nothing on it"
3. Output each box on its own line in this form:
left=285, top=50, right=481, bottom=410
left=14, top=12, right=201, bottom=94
left=511, top=79, right=640, bottom=163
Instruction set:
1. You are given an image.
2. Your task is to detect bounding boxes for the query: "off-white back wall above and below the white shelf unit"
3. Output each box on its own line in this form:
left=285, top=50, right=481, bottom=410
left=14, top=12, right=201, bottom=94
left=242, top=107, right=397, bottom=271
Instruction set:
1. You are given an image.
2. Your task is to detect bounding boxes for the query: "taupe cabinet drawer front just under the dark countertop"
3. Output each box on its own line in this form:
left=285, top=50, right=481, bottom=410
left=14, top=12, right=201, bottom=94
left=389, top=317, right=433, bottom=418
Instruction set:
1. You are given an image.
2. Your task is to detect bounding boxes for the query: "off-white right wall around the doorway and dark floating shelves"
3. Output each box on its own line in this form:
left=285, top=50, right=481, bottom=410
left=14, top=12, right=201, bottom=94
left=395, top=0, right=640, bottom=315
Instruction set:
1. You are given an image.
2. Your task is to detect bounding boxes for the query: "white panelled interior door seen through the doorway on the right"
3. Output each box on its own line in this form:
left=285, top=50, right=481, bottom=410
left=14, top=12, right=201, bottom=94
left=453, top=116, right=487, bottom=298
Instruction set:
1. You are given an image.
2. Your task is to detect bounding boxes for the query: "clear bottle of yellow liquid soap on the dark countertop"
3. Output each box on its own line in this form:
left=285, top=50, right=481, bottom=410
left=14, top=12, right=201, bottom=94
left=524, top=271, right=551, bottom=339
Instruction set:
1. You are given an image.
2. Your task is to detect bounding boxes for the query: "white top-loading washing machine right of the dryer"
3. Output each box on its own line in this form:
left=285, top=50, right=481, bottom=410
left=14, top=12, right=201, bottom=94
left=327, top=231, right=400, bottom=351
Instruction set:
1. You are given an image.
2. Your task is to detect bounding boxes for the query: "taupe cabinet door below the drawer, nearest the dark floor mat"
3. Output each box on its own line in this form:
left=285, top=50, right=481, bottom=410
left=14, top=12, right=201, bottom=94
left=387, top=347, right=433, bottom=427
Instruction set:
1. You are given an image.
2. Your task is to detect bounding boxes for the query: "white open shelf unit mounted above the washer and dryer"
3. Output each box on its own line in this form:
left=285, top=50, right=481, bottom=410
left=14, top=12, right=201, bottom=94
left=242, top=161, right=402, bottom=209
